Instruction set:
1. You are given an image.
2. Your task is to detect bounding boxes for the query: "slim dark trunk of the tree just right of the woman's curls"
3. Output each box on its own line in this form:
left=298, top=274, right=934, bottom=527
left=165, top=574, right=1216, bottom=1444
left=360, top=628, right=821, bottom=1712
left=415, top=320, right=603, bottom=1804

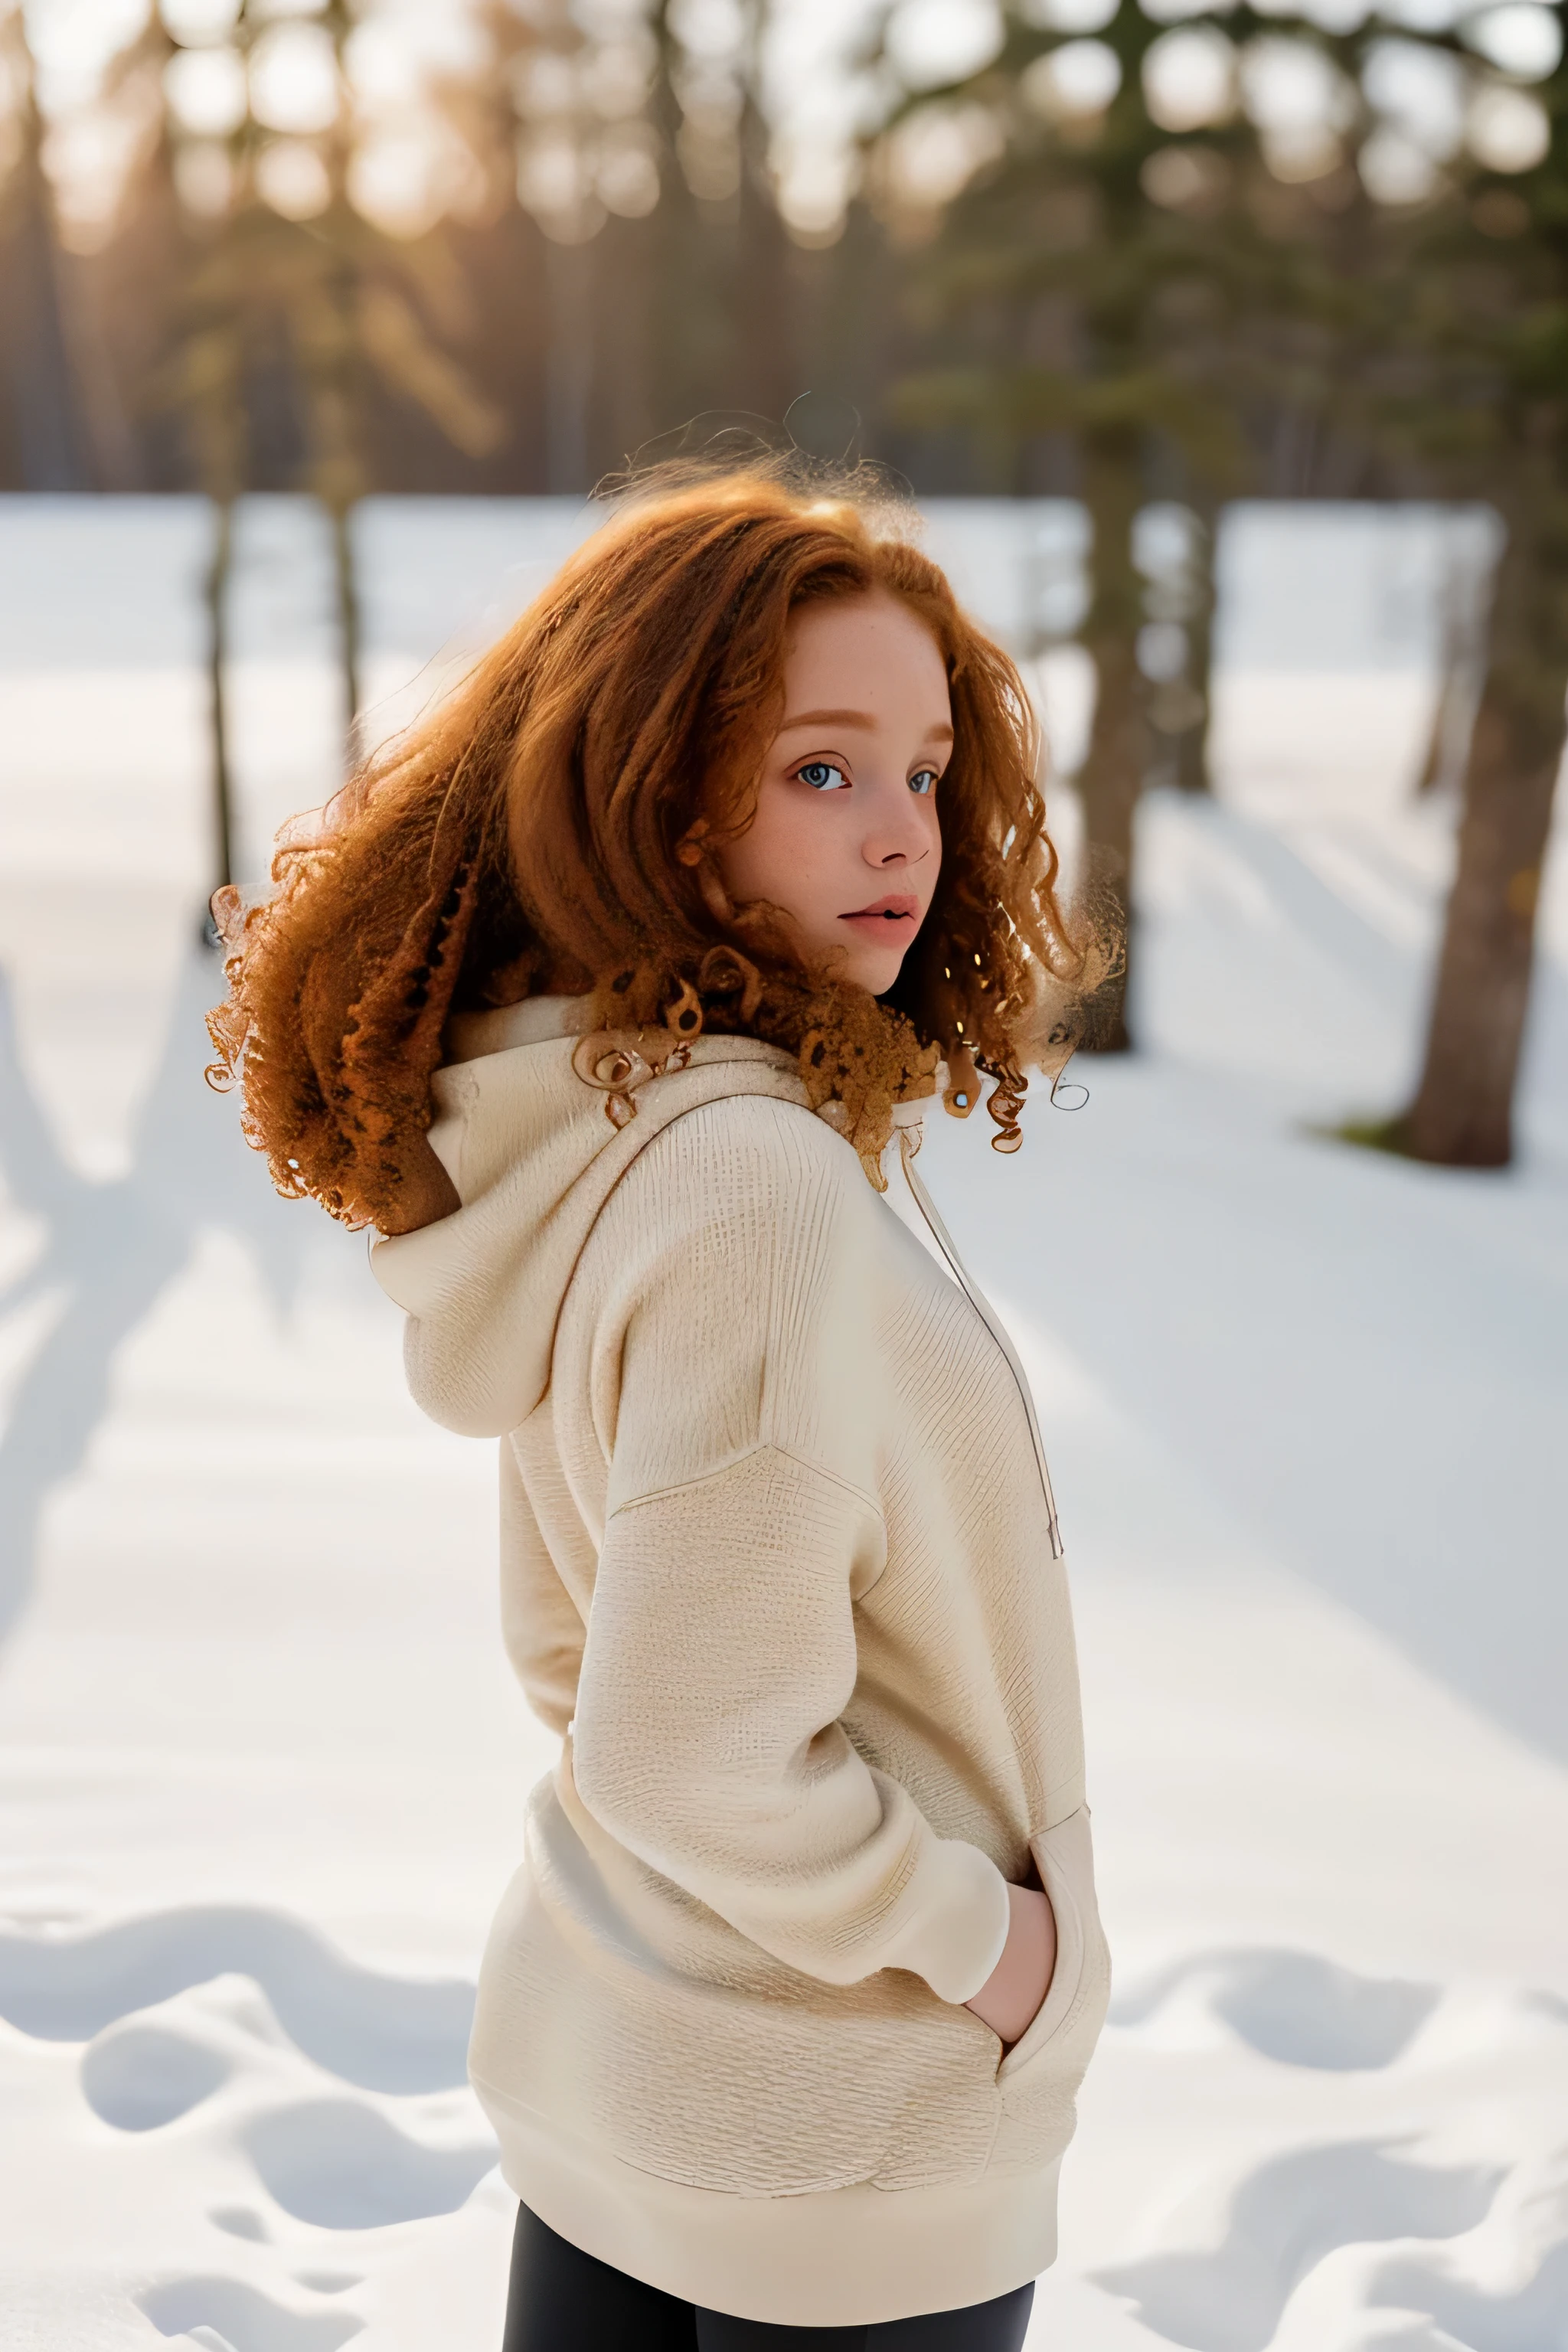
left=1076, top=433, right=1149, bottom=1054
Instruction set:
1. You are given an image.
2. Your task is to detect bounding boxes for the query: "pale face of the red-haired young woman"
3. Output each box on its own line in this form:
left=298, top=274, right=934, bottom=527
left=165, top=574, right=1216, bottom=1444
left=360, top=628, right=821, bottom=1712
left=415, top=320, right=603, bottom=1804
left=717, top=590, right=952, bottom=995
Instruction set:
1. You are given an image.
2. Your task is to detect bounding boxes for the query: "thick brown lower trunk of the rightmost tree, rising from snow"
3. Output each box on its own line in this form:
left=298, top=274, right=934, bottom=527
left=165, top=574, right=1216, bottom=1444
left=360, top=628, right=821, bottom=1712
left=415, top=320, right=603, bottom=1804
left=1385, top=514, right=1568, bottom=1169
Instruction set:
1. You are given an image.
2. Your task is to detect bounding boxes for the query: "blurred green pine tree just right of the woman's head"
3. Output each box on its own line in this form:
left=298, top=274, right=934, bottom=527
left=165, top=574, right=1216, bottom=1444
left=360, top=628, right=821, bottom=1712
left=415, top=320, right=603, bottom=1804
left=887, top=0, right=1272, bottom=1051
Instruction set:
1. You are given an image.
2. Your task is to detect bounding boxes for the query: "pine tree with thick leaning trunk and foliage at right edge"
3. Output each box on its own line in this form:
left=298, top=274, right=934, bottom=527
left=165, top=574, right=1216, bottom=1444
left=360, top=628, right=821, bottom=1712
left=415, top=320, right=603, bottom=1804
left=1325, top=7, right=1568, bottom=1167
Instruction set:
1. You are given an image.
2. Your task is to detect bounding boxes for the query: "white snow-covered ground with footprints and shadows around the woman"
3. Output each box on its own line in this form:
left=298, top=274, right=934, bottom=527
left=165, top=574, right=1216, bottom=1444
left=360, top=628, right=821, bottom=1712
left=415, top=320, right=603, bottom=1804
left=0, top=501, right=1568, bottom=2352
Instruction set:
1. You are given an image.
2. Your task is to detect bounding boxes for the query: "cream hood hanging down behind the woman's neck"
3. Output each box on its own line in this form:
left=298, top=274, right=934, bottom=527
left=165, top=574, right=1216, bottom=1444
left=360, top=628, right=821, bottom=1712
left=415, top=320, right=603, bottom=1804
left=371, top=998, right=808, bottom=1437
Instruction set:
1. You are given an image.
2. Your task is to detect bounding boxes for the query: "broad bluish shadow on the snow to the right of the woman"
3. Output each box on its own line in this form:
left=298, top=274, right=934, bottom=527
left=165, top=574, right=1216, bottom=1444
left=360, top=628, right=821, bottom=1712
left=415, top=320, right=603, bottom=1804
left=933, top=809, right=1568, bottom=1762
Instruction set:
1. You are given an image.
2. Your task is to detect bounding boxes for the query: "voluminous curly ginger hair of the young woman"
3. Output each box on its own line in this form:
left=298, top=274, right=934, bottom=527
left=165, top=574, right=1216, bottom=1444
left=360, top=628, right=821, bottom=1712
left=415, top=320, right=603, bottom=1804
left=209, top=468, right=1086, bottom=1233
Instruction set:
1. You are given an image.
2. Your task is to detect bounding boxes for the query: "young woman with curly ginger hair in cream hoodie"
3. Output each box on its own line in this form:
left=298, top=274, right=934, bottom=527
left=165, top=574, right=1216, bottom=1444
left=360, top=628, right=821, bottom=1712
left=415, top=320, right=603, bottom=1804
left=214, top=475, right=1107, bottom=2352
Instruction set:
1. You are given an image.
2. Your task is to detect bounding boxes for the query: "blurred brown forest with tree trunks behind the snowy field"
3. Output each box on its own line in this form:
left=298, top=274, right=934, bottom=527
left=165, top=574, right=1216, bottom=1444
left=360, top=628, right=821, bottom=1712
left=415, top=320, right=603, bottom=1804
left=0, top=0, right=1568, bottom=1167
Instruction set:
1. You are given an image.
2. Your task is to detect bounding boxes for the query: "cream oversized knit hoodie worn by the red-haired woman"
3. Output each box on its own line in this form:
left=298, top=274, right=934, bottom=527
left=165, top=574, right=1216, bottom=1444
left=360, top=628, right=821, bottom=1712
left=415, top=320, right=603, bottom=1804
left=374, top=1000, right=1107, bottom=2326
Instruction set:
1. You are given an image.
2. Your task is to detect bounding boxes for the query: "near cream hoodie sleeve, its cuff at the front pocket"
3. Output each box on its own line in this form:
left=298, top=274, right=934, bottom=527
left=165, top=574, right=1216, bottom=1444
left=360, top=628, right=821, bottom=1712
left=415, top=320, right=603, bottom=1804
left=571, top=1096, right=1008, bottom=2001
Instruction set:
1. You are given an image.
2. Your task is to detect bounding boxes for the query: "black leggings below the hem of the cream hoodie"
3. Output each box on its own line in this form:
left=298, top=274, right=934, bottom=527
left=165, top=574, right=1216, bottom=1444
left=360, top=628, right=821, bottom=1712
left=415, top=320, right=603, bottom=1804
left=503, top=2207, right=1034, bottom=2352
